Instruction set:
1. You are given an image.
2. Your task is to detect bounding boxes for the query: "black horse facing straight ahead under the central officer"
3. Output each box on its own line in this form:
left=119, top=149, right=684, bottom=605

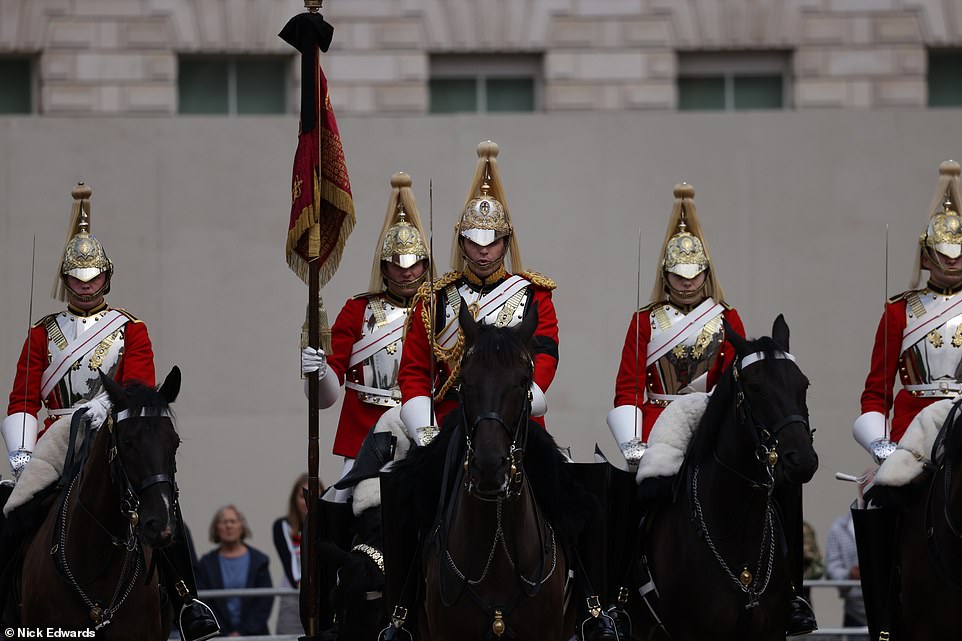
left=388, top=303, right=584, bottom=641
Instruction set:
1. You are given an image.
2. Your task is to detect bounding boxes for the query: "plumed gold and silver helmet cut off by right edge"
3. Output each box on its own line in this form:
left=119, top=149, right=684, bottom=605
left=912, top=160, right=962, bottom=288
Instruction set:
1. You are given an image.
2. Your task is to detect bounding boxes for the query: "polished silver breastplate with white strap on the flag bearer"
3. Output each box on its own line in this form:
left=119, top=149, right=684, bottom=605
left=354, top=296, right=409, bottom=407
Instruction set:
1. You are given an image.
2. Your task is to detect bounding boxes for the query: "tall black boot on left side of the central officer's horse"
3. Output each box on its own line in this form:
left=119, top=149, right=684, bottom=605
left=377, top=464, right=420, bottom=641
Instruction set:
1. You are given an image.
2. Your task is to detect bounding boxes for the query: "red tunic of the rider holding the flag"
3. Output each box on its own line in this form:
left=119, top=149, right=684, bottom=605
left=327, top=297, right=398, bottom=458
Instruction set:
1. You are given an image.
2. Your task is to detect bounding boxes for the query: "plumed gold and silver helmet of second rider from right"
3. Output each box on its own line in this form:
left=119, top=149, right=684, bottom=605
left=651, top=182, right=724, bottom=302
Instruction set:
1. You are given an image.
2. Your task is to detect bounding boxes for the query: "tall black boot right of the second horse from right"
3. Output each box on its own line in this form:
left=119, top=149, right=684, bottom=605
left=773, top=484, right=818, bottom=637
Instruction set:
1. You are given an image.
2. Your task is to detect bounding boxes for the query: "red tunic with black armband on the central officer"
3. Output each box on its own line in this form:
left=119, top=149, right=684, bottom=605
left=398, top=281, right=558, bottom=425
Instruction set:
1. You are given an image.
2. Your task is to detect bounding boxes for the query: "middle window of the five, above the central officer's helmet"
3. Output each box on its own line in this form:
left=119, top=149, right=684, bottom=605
left=429, top=54, right=543, bottom=114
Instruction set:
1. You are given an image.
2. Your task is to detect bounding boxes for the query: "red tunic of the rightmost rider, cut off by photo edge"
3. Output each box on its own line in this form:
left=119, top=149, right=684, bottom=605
left=861, top=298, right=928, bottom=443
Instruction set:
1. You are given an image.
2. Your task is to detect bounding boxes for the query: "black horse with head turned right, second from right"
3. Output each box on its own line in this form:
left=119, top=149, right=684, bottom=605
left=639, top=315, right=818, bottom=641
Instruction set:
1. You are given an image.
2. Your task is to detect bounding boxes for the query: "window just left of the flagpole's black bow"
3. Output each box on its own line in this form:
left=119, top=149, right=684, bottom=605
left=177, top=56, right=291, bottom=115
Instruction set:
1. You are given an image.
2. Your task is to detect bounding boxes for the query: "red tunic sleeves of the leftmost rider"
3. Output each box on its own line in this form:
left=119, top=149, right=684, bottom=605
left=7, top=320, right=156, bottom=434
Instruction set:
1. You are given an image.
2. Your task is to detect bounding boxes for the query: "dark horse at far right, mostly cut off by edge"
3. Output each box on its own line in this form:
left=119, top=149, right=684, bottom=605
left=892, top=402, right=962, bottom=641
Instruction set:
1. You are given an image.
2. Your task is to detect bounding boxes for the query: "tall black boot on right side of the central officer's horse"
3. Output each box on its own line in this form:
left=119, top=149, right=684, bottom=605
left=568, top=463, right=627, bottom=641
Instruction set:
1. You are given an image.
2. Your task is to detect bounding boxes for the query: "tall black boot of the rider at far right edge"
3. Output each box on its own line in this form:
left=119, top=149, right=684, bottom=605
left=852, top=506, right=899, bottom=641
